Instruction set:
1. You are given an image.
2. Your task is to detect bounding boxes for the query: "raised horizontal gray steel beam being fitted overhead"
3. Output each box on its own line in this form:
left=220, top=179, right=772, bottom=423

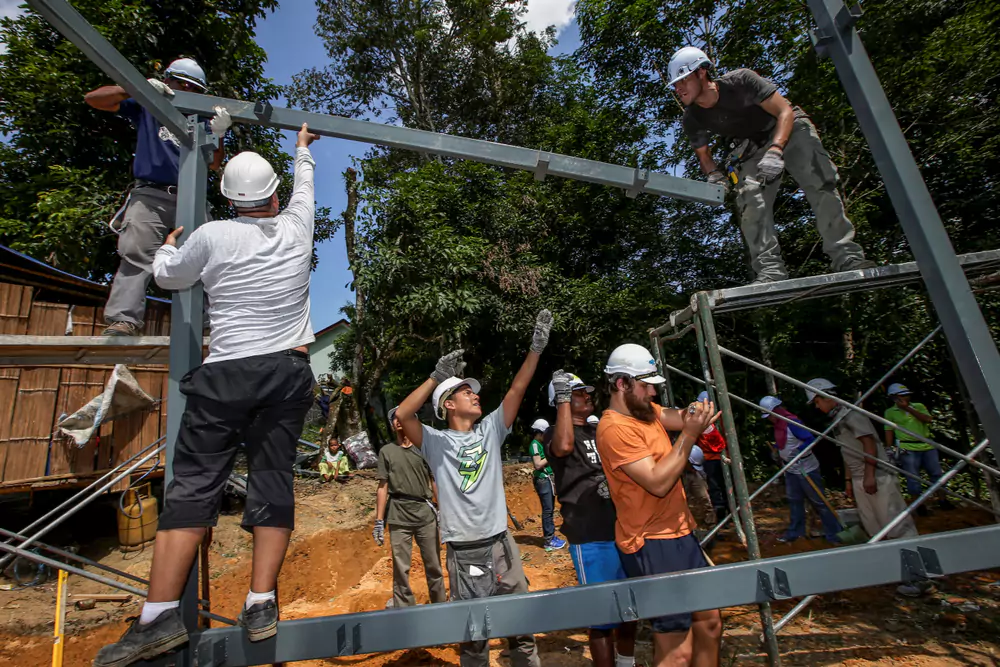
left=171, top=92, right=724, bottom=206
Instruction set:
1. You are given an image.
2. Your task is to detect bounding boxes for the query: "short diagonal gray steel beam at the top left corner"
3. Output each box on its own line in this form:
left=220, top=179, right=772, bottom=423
left=26, top=0, right=191, bottom=146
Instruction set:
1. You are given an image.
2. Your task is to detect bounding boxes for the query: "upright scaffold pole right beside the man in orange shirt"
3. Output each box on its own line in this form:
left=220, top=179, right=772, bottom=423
left=695, top=292, right=781, bottom=666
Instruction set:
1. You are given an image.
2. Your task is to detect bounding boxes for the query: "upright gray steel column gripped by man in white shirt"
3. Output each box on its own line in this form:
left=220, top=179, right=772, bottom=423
left=164, top=116, right=212, bottom=656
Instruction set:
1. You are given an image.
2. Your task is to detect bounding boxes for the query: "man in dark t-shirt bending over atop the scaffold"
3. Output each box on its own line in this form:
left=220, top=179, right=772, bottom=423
left=667, top=46, right=875, bottom=283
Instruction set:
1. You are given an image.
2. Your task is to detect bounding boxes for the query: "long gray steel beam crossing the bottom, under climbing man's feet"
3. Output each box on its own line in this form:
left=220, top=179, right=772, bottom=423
left=186, top=526, right=1000, bottom=667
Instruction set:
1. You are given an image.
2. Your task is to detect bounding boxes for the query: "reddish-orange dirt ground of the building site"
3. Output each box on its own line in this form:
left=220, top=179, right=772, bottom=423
left=0, top=466, right=1000, bottom=667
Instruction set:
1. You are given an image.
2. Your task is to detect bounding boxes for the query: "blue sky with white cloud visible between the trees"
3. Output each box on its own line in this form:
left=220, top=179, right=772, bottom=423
left=254, top=0, right=579, bottom=331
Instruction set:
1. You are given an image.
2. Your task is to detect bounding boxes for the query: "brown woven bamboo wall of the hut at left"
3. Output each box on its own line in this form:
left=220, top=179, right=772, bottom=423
left=0, top=283, right=170, bottom=491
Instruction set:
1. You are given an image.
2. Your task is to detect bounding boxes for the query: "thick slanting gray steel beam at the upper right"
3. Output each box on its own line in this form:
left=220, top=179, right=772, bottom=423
left=808, top=0, right=1000, bottom=461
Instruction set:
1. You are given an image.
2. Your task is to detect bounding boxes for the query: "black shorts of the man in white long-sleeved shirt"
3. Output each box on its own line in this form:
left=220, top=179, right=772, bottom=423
left=159, top=352, right=313, bottom=530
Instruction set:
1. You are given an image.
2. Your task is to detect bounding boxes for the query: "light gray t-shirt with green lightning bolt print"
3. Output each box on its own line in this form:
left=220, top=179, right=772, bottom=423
left=420, top=404, right=510, bottom=542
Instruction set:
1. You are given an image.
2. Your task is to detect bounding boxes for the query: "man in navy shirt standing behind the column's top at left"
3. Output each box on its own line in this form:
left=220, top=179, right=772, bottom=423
left=84, top=58, right=232, bottom=336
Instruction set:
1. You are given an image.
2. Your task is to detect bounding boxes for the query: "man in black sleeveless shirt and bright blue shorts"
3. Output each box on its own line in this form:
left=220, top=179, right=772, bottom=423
left=545, top=370, right=636, bottom=667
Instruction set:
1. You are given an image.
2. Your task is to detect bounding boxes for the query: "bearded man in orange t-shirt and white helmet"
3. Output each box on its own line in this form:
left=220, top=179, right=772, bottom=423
left=597, top=343, right=722, bottom=667
